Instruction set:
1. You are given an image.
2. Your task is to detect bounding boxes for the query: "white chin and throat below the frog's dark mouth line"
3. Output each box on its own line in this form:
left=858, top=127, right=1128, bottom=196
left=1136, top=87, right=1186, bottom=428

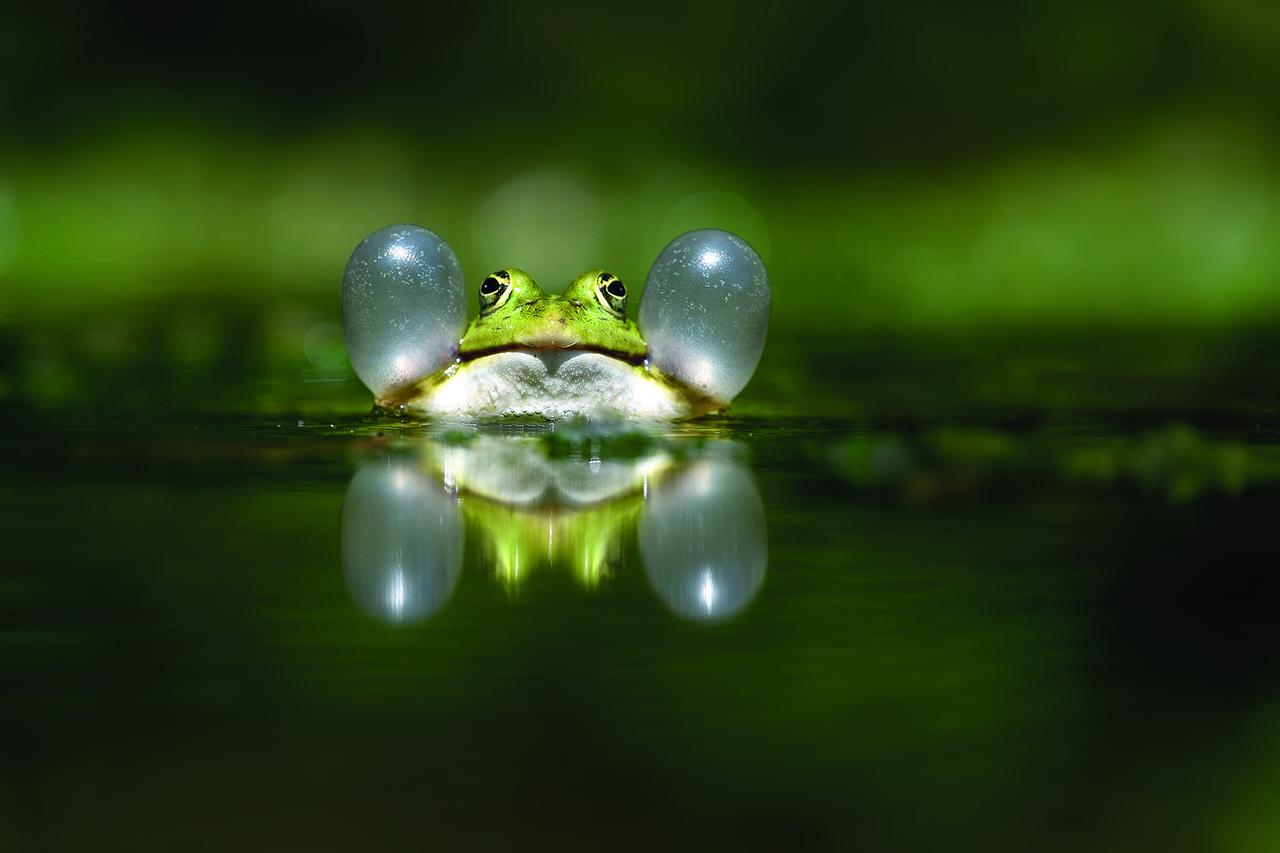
left=403, top=347, right=708, bottom=420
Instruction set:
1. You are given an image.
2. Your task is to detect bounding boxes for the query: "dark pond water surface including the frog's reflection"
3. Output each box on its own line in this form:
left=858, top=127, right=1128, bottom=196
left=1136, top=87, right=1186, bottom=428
left=0, top=322, right=1280, bottom=850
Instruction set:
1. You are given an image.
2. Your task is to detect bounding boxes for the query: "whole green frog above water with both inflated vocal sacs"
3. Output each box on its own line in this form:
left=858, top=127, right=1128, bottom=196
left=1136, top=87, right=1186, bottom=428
left=342, top=224, right=771, bottom=421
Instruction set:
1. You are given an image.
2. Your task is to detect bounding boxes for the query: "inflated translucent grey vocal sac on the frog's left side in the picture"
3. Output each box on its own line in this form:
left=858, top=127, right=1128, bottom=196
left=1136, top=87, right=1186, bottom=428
left=342, top=225, right=467, bottom=397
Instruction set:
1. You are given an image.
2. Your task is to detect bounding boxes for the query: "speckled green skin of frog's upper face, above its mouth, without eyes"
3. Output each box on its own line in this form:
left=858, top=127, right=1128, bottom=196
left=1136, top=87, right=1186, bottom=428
left=458, top=269, right=648, bottom=364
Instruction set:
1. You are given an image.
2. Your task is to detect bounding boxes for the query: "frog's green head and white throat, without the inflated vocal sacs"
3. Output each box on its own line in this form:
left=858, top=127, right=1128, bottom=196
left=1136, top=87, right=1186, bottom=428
left=378, top=266, right=726, bottom=420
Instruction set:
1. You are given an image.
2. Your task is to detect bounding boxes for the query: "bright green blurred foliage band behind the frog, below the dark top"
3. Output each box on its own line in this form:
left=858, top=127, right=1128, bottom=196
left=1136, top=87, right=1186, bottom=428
left=0, top=120, right=1280, bottom=330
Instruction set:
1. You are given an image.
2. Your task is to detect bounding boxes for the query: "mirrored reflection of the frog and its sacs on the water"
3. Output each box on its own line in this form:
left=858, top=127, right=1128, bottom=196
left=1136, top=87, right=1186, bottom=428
left=342, top=434, right=768, bottom=622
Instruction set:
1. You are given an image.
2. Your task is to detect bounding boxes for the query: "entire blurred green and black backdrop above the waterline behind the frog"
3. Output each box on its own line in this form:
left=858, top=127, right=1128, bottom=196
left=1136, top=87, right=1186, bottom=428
left=0, top=0, right=1280, bottom=338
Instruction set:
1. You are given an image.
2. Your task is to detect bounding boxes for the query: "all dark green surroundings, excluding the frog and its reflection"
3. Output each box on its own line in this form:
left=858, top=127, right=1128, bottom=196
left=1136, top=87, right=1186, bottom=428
left=0, top=0, right=1280, bottom=853
